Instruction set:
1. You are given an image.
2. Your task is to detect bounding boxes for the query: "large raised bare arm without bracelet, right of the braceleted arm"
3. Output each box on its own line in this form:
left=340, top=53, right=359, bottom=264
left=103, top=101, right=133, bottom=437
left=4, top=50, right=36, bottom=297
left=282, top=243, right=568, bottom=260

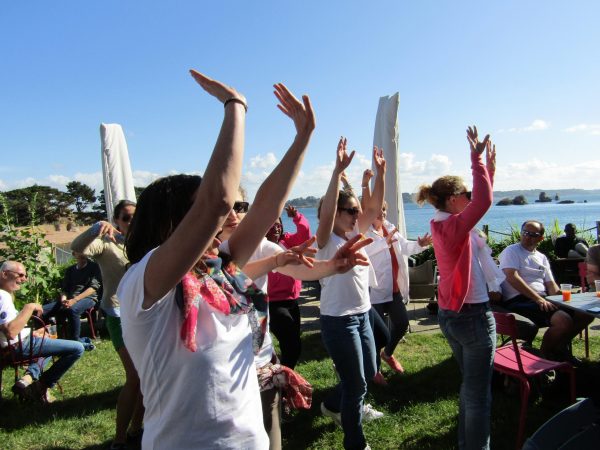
left=229, top=83, right=315, bottom=267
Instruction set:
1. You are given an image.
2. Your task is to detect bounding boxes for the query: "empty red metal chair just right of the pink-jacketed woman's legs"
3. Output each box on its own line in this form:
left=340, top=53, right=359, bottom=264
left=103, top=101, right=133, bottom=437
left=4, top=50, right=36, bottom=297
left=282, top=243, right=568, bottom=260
left=494, top=312, right=575, bottom=449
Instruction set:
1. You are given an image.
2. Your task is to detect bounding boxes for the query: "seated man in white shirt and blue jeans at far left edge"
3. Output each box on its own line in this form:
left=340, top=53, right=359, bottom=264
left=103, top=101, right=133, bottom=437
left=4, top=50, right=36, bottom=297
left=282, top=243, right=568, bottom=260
left=0, top=261, right=84, bottom=403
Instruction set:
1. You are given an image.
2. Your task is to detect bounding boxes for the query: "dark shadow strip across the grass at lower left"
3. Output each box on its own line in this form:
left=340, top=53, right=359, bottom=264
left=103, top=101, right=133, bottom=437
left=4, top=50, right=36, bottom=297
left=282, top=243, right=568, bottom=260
left=0, top=386, right=121, bottom=431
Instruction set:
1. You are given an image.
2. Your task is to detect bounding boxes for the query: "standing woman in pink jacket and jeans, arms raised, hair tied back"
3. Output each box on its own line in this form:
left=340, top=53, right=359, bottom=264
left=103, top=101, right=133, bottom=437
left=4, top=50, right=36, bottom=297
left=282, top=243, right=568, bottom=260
left=417, top=127, right=496, bottom=450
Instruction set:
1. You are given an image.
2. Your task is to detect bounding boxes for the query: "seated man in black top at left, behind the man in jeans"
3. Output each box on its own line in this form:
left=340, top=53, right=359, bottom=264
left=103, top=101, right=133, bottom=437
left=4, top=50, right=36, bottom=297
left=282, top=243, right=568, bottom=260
left=42, top=252, right=101, bottom=344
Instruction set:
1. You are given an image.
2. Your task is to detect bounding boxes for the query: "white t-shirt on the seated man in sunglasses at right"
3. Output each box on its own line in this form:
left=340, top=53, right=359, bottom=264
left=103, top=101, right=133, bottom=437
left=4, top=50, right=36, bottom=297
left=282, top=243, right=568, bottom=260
left=498, top=243, right=554, bottom=300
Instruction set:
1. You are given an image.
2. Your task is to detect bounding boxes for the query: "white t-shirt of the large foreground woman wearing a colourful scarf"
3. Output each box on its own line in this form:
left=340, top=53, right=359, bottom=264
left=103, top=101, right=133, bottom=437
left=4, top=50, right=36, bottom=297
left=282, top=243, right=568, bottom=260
left=117, top=251, right=269, bottom=450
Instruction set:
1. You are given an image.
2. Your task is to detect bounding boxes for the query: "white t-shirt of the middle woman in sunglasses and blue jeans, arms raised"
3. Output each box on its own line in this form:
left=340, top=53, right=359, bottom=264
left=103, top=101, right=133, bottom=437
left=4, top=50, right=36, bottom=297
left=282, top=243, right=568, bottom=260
left=316, top=232, right=371, bottom=317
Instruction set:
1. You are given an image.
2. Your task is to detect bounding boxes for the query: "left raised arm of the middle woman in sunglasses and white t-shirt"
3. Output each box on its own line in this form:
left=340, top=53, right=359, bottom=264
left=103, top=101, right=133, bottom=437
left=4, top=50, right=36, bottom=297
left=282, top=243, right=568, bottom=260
left=317, top=136, right=355, bottom=248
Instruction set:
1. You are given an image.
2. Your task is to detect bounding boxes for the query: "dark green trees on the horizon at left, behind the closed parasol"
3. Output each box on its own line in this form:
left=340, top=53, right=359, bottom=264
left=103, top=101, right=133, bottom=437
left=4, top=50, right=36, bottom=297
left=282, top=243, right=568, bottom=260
left=0, top=181, right=144, bottom=226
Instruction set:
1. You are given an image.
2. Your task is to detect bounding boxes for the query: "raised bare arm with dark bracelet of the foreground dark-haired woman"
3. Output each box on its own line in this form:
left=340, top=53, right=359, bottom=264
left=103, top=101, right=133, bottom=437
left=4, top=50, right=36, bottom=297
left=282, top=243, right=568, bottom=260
left=143, top=70, right=247, bottom=308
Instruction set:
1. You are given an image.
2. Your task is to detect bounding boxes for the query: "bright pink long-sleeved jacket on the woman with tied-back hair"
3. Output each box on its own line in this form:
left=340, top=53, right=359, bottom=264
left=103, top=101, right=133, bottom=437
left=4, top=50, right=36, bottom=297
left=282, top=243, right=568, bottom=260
left=431, top=152, right=494, bottom=311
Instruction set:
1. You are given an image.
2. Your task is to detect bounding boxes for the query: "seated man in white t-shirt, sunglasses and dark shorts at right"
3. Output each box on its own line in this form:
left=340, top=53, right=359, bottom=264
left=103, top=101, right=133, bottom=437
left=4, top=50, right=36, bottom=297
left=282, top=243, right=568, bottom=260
left=499, top=220, right=593, bottom=361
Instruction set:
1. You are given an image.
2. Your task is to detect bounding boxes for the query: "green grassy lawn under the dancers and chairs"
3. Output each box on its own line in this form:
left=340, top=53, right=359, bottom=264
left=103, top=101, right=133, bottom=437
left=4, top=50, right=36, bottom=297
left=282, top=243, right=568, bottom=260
left=0, top=326, right=600, bottom=450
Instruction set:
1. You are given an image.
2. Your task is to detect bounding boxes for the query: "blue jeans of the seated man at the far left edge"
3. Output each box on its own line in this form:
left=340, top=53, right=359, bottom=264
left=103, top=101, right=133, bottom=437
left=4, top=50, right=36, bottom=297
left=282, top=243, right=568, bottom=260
left=21, top=337, right=84, bottom=387
